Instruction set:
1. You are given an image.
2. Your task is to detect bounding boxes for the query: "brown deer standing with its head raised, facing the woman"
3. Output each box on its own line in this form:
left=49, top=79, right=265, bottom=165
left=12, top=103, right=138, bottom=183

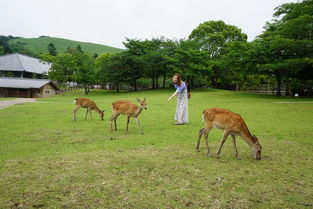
left=111, top=98, right=147, bottom=134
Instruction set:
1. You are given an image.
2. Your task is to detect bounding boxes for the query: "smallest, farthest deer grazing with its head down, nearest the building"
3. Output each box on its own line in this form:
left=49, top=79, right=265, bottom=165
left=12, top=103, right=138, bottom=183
left=73, top=98, right=104, bottom=121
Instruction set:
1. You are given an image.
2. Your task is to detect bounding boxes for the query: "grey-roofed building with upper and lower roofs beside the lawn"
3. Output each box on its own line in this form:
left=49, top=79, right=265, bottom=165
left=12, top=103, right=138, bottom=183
left=0, top=54, right=59, bottom=98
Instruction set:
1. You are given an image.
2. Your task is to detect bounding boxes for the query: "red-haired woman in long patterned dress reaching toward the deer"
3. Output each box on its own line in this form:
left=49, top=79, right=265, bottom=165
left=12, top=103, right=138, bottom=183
left=168, top=73, right=188, bottom=125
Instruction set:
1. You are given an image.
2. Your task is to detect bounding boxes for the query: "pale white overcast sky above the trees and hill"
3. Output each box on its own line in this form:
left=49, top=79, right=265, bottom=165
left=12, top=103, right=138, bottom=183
left=0, top=0, right=296, bottom=48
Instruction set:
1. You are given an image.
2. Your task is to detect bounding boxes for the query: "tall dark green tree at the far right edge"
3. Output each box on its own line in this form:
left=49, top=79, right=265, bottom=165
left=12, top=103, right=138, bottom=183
left=256, top=0, right=313, bottom=95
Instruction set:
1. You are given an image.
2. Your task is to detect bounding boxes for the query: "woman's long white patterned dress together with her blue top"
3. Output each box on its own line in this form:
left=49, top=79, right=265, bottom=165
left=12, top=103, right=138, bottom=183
left=174, top=82, right=188, bottom=123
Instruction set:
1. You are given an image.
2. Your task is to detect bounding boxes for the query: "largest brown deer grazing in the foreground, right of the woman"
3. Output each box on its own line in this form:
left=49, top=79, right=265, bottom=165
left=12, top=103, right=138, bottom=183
left=196, top=108, right=262, bottom=160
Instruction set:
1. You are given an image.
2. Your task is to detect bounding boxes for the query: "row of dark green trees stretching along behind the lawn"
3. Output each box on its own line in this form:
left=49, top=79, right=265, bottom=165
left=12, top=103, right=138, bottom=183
left=3, top=0, right=313, bottom=95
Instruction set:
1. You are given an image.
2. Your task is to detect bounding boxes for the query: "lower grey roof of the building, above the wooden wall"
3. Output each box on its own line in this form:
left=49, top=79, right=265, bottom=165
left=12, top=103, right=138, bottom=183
left=0, top=78, right=58, bottom=89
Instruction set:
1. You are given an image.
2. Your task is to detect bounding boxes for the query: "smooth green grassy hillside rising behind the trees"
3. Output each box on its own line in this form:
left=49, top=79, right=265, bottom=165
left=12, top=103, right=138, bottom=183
left=8, top=37, right=122, bottom=56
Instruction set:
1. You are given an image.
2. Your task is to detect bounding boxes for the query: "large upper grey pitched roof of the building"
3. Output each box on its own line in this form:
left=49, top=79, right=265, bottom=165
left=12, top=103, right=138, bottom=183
left=0, top=53, right=51, bottom=74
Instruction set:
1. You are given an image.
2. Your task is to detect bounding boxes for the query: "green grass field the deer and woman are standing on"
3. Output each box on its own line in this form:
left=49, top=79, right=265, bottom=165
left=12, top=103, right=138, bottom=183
left=0, top=90, right=313, bottom=209
